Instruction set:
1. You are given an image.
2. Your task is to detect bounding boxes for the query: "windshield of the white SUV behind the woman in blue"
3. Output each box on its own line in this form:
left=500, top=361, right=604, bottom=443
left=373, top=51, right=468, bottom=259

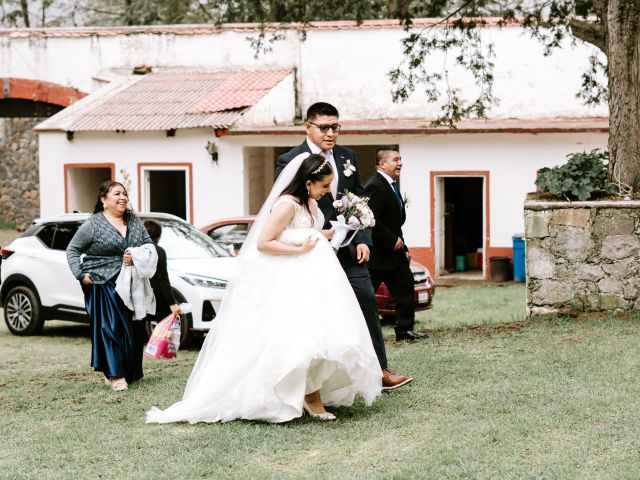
left=142, top=218, right=231, bottom=259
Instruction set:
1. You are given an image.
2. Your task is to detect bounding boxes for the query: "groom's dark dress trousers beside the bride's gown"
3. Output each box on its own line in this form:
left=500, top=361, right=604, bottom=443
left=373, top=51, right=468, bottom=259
left=342, top=263, right=387, bottom=369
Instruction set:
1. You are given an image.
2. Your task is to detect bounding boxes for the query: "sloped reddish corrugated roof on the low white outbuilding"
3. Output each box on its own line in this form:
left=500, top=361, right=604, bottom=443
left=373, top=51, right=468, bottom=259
left=37, top=69, right=291, bottom=132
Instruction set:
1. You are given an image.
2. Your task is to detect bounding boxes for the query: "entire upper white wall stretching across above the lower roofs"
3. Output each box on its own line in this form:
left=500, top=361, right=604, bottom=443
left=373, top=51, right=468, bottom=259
left=0, top=27, right=607, bottom=122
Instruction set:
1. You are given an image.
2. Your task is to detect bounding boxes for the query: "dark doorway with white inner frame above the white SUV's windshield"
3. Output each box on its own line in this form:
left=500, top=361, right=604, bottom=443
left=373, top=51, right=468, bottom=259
left=139, top=165, right=193, bottom=222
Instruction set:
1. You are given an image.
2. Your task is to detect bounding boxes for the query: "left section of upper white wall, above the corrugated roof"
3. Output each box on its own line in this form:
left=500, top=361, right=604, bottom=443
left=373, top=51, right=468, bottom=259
left=0, top=30, right=298, bottom=93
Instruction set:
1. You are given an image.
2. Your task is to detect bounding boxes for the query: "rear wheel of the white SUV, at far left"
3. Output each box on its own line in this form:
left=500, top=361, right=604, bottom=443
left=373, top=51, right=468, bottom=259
left=3, top=286, right=44, bottom=335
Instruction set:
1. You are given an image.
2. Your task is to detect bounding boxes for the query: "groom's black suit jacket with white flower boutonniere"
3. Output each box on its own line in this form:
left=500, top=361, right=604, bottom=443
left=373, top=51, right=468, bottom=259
left=275, top=140, right=371, bottom=266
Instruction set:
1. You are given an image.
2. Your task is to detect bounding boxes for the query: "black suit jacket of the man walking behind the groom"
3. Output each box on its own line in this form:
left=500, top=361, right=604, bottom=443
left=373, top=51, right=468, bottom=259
left=365, top=172, right=408, bottom=270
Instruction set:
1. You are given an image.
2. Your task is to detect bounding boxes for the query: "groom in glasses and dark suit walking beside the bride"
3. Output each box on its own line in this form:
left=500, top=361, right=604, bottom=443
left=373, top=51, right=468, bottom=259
left=276, top=102, right=413, bottom=390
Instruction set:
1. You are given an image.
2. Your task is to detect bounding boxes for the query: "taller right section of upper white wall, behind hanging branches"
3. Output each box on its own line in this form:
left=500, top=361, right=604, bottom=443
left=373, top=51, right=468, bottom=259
left=299, top=27, right=607, bottom=119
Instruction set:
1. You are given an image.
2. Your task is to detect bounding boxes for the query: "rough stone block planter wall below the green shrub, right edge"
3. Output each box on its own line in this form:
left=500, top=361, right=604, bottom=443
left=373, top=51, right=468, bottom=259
left=524, top=201, right=640, bottom=315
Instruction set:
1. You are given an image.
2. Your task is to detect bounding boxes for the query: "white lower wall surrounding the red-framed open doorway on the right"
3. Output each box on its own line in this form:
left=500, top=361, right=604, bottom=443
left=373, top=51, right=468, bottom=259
left=398, top=133, right=607, bottom=247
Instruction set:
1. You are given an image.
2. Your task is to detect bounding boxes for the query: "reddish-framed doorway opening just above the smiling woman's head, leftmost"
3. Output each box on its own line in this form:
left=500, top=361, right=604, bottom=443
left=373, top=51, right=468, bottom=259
left=64, top=163, right=115, bottom=213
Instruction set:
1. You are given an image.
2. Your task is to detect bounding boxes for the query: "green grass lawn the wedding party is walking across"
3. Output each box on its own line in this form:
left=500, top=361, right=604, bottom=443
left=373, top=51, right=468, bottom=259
left=0, top=286, right=640, bottom=479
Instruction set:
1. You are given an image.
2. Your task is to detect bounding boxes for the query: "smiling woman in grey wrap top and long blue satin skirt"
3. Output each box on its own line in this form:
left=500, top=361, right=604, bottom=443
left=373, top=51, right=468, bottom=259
left=67, top=181, right=152, bottom=391
